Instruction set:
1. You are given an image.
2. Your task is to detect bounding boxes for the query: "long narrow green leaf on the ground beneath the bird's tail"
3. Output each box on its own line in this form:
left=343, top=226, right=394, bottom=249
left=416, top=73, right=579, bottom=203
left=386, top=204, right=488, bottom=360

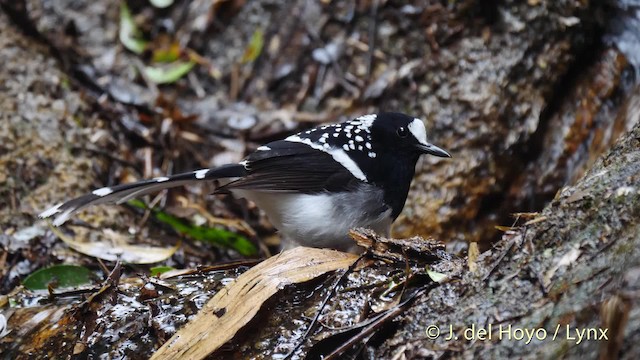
left=127, top=199, right=258, bottom=256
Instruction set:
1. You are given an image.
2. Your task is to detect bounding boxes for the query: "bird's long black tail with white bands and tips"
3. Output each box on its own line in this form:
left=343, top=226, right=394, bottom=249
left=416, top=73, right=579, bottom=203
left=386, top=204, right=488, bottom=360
left=38, top=164, right=246, bottom=226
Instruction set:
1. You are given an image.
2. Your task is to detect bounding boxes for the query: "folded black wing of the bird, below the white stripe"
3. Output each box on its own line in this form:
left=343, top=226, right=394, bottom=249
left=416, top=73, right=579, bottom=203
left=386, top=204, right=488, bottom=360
left=217, top=140, right=361, bottom=194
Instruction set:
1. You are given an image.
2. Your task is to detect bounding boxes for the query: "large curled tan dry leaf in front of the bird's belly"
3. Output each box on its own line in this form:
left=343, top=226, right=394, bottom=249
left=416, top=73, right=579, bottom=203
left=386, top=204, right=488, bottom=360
left=151, top=247, right=358, bottom=359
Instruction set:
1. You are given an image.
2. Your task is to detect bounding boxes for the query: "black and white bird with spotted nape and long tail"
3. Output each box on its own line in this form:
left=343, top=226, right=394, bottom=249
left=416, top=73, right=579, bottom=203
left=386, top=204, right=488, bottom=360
left=40, top=113, right=450, bottom=250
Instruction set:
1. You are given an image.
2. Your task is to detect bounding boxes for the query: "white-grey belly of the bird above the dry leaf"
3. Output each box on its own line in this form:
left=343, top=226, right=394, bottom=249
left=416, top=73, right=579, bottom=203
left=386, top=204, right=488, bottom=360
left=233, top=189, right=391, bottom=251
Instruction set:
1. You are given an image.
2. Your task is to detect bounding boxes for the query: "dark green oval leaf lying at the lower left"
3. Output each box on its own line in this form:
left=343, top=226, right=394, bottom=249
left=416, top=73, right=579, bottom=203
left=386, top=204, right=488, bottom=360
left=22, top=265, right=93, bottom=290
